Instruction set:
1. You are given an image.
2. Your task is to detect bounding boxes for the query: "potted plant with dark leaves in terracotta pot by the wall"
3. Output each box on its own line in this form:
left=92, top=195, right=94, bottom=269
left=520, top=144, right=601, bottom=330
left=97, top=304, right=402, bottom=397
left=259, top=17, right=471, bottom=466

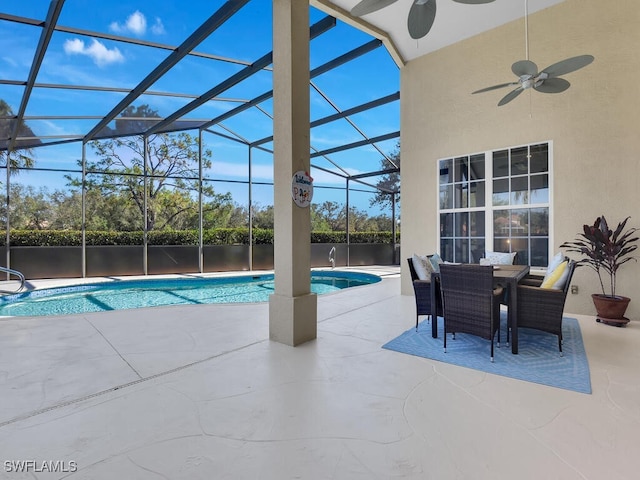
left=560, top=215, right=638, bottom=327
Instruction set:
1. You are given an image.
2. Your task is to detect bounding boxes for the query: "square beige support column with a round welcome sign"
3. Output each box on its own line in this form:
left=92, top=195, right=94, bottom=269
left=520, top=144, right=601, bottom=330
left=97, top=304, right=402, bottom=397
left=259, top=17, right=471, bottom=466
left=269, top=0, right=318, bottom=346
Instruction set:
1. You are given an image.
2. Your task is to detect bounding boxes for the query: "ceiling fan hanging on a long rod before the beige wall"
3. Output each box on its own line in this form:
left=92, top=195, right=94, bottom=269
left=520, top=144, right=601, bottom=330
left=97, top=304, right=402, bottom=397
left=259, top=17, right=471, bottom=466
left=472, top=0, right=594, bottom=107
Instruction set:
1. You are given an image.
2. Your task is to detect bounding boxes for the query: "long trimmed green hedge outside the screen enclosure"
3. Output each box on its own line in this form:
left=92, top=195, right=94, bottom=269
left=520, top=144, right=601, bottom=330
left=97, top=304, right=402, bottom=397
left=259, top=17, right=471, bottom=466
left=0, top=228, right=400, bottom=247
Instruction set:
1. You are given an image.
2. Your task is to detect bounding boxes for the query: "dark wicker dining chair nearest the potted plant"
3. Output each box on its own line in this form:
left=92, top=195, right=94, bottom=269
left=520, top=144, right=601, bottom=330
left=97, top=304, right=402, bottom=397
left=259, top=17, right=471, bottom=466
left=518, top=258, right=576, bottom=356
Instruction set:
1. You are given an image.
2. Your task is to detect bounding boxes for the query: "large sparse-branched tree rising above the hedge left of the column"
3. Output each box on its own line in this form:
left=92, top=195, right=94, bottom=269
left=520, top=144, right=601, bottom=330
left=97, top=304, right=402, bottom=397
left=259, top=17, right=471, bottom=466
left=67, top=105, right=230, bottom=230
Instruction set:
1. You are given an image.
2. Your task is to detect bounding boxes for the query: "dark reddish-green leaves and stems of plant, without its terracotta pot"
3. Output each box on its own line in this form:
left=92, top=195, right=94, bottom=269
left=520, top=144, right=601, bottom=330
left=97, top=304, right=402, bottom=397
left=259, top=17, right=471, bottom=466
left=560, top=215, right=638, bottom=297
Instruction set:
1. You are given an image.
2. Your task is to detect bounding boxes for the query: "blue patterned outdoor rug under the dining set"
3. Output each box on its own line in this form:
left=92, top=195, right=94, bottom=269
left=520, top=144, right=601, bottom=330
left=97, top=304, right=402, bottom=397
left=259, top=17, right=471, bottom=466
left=382, top=312, right=591, bottom=393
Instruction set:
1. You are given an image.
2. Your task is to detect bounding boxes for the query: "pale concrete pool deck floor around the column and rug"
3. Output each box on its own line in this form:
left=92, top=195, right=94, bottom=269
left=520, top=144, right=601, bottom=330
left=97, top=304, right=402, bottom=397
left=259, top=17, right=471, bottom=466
left=0, top=267, right=640, bottom=480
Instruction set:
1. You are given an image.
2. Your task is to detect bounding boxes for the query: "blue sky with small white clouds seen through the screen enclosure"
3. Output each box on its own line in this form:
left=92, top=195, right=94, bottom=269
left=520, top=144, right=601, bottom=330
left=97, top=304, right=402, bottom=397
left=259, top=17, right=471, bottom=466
left=0, top=0, right=400, bottom=214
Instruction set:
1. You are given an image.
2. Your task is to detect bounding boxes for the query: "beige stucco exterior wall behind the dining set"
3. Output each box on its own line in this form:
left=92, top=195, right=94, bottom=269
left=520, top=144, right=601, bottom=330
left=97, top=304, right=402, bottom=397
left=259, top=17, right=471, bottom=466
left=401, top=0, right=640, bottom=320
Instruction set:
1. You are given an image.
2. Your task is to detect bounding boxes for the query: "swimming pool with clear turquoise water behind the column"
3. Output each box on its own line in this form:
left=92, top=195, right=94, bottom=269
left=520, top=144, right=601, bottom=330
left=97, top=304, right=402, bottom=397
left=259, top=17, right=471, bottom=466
left=0, top=271, right=380, bottom=316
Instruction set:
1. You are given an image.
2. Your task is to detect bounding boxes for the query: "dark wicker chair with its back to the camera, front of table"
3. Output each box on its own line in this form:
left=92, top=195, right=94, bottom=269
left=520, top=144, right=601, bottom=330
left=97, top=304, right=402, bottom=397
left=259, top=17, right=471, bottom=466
left=440, top=264, right=503, bottom=362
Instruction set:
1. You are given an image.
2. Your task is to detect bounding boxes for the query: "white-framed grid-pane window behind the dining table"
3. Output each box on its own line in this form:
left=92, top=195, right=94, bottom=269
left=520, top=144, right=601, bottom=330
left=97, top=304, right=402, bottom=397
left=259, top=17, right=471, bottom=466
left=438, top=142, right=552, bottom=267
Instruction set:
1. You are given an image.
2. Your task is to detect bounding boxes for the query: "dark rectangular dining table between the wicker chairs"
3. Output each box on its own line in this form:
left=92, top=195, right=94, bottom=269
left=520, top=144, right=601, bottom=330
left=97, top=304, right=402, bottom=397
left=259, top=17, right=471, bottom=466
left=431, top=265, right=529, bottom=354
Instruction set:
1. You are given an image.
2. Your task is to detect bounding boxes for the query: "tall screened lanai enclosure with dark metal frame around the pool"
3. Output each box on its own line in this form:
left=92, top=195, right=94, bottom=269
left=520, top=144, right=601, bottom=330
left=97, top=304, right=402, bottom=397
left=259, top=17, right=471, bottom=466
left=0, top=0, right=400, bottom=278
